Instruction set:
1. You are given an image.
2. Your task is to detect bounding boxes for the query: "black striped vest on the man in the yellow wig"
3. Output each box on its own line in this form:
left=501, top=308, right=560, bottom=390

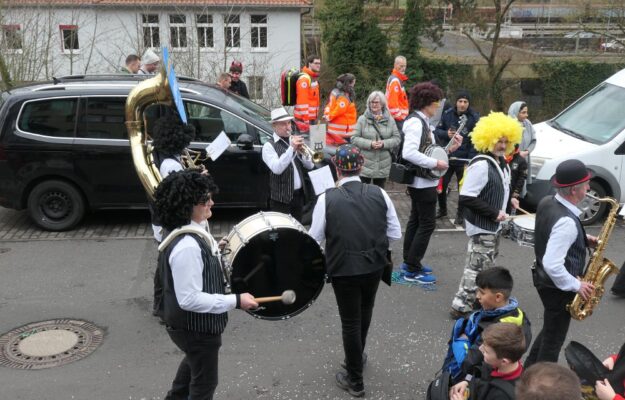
left=464, top=154, right=510, bottom=233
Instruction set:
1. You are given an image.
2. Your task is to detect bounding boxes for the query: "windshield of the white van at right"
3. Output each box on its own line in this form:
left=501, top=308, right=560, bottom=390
left=549, top=82, right=625, bottom=144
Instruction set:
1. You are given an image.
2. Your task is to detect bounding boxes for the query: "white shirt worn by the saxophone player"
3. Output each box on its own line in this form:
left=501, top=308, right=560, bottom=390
left=543, top=194, right=582, bottom=292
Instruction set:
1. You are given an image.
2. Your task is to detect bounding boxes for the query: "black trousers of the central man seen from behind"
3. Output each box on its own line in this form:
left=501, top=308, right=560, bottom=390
left=332, top=268, right=383, bottom=384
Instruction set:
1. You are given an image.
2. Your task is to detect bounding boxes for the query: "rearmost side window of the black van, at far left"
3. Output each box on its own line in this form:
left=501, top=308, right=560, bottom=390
left=17, top=98, right=78, bottom=137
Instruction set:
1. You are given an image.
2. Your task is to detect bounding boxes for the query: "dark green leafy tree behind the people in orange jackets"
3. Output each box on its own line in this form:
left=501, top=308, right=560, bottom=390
left=318, top=0, right=392, bottom=106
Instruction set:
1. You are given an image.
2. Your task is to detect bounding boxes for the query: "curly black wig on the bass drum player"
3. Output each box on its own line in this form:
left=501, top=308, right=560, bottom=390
left=154, top=169, right=219, bottom=231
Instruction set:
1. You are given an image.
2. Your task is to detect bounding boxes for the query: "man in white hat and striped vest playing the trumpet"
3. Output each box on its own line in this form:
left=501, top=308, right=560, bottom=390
left=263, top=107, right=314, bottom=222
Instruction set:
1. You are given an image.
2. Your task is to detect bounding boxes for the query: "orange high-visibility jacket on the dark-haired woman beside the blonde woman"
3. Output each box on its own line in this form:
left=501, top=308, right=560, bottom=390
left=323, top=88, right=358, bottom=146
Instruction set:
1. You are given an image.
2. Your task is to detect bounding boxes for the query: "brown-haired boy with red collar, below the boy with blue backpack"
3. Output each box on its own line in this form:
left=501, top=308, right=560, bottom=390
left=449, top=323, right=526, bottom=400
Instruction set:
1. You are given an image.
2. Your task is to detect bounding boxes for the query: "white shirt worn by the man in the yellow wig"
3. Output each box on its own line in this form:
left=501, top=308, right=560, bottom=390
left=460, top=160, right=510, bottom=236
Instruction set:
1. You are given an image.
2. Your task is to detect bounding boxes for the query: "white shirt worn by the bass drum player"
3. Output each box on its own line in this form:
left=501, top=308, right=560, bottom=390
left=169, top=222, right=237, bottom=314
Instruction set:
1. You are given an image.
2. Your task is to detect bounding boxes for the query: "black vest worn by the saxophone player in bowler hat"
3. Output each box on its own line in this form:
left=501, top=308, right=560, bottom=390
left=534, top=196, right=587, bottom=288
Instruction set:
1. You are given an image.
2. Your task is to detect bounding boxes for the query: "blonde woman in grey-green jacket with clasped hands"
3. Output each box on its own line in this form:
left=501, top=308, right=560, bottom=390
left=352, top=91, right=400, bottom=188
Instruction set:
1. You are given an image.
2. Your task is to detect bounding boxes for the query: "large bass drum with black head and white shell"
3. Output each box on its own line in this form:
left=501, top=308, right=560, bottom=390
left=223, top=212, right=326, bottom=320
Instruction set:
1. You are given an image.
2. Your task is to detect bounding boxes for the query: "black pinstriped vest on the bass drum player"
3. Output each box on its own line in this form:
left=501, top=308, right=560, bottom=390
left=158, top=233, right=228, bottom=335
